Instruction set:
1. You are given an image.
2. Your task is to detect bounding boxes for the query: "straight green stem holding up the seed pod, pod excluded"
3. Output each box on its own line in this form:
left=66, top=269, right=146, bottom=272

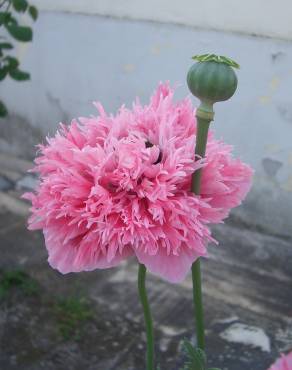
left=191, top=105, right=213, bottom=350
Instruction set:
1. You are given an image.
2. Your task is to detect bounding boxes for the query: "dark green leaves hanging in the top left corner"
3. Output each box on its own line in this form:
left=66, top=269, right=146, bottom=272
left=0, top=0, right=38, bottom=117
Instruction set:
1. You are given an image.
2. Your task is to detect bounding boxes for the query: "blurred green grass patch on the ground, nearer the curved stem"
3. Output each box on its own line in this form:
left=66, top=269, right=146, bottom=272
left=55, top=297, right=93, bottom=340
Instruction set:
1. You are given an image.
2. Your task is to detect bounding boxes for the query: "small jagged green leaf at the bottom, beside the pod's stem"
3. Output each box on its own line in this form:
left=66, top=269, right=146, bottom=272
left=181, top=339, right=220, bottom=370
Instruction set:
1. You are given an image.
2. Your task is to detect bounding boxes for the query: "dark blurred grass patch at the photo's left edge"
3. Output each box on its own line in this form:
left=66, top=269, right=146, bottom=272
left=0, top=270, right=39, bottom=298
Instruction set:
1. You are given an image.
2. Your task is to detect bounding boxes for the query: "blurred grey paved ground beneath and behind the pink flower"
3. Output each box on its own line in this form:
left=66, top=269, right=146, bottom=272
left=0, top=155, right=292, bottom=370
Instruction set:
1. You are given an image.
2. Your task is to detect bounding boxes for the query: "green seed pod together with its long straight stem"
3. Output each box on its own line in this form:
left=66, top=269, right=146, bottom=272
left=187, top=54, right=239, bottom=356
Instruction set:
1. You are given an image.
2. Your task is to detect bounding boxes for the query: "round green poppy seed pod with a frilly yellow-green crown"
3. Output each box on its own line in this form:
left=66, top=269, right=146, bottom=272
left=187, top=54, right=239, bottom=105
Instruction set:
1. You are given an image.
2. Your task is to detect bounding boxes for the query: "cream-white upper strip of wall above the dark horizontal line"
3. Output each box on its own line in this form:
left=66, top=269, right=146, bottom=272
left=34, top=0, right=292, bottom=40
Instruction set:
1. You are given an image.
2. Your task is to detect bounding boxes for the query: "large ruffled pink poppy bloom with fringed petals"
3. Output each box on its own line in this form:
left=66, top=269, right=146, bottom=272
left=25, top=84, right=252, bottom=282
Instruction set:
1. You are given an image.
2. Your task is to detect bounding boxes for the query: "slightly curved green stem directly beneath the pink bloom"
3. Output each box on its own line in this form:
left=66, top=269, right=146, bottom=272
left=138, top=263, right=154, bottom=370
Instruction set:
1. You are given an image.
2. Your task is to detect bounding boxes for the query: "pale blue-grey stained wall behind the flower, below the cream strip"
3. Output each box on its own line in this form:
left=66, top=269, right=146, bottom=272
left=0, top=11, right=292, bottom=235
